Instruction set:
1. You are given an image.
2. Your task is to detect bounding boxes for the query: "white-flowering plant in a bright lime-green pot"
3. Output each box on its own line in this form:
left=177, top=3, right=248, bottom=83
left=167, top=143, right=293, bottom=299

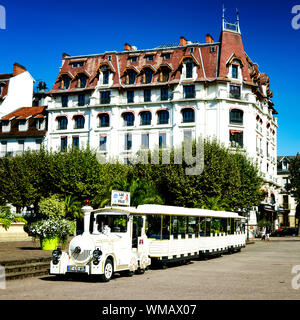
left=29, top=218, right=71, bottom=250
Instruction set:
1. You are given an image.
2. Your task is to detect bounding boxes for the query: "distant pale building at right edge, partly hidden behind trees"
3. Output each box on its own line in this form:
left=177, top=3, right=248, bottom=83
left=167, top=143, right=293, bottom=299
left=277, top=156, right=299, bottom=227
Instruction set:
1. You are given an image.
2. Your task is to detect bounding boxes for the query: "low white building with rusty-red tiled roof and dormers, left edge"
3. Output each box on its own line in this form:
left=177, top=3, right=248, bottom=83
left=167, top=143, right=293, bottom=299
left=0, top=106, right=47, bottom=157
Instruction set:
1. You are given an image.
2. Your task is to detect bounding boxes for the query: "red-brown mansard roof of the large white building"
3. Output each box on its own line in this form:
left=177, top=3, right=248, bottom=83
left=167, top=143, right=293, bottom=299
left=50, top=24, right=273, bottom=107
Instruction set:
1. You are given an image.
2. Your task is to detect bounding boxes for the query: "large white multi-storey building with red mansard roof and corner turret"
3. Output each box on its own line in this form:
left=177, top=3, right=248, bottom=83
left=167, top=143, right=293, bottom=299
left=48, top=13, right=279, bottom=229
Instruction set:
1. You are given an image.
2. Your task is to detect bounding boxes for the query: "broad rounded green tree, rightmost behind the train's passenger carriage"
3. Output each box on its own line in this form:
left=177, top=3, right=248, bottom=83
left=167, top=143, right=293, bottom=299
left=133, top=139, right=262, bottom=211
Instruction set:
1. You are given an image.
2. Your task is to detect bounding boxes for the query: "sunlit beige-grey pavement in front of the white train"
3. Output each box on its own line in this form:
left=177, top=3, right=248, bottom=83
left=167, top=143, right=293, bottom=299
left=0, top=239, right=300, bottom=300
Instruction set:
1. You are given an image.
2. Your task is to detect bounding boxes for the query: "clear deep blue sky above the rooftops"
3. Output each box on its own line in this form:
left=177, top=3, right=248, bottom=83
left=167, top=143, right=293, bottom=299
left=0, top=0, right=300, bottom=155
